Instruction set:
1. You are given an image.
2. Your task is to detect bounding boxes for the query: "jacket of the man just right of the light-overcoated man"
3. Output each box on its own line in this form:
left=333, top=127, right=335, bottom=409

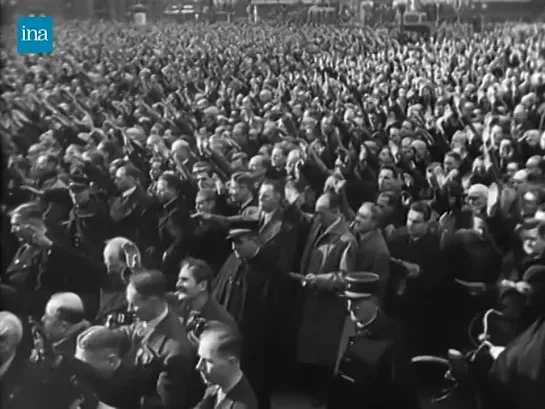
left=356, top=229, right=390, bottom=300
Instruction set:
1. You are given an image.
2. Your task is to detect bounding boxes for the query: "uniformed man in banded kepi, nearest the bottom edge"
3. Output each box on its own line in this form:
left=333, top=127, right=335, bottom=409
left=327, top=272, right=419, bottom=409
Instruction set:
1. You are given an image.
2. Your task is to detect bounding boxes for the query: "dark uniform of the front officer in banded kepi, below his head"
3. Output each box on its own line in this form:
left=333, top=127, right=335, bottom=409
left=327, top=310, right=419, bottom=409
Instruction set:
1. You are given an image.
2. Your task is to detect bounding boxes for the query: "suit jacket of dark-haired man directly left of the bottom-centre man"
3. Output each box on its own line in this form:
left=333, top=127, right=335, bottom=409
left=124, top=311, right=204, bottom=409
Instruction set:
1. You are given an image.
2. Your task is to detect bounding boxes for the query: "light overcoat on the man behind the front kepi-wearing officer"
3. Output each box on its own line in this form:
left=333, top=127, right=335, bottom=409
left=298, top=216, right=357, bottom=367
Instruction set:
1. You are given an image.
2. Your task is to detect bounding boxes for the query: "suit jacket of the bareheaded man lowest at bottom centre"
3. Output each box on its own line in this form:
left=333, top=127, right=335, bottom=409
left=194, top=376, right=258, bottom=409
